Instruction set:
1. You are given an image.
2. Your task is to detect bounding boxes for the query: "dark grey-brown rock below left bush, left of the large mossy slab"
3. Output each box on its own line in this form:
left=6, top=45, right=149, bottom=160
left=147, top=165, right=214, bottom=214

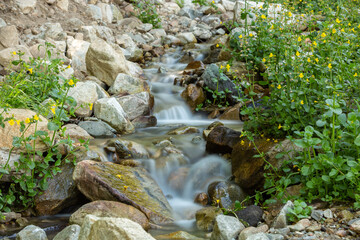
left=35, top=163, right=80, bottom=215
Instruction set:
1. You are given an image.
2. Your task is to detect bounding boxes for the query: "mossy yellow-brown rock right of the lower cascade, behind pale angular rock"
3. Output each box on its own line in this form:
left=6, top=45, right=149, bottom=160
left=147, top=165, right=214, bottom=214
left=195, top=207, right=222, bottom=232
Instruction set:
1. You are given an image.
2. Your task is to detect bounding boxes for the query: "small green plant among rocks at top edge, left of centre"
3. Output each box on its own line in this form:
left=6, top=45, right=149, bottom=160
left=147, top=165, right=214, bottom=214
left=135, top=0, right=161, bottom=28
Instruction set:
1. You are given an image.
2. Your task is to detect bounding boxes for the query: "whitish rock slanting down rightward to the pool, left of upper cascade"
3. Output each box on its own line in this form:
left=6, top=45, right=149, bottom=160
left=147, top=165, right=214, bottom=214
left=94, top=97, right=134, bottom=134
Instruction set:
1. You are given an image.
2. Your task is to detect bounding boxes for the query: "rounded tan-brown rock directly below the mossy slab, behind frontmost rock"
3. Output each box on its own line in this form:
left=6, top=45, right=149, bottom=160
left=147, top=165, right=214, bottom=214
left=69, top=200, right=149, bottom=230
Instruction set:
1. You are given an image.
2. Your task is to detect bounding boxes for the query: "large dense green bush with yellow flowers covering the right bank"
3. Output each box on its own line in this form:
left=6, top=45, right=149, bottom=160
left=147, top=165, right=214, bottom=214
left=221, top=0, right=360, bottom=208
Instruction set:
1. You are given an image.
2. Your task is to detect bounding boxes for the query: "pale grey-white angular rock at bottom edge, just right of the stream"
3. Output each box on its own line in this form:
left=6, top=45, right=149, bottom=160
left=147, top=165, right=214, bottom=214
left=210, top=215, right=245, bottom=240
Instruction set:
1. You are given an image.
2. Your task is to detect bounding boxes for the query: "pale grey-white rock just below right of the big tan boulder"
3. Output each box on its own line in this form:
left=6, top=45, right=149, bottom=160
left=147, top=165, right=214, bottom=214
left=109, top=73, right=149, bottom=96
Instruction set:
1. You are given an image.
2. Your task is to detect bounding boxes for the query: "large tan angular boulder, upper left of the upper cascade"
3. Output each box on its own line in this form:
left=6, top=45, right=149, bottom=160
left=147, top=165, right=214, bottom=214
left=85, top=39, right=129, bottom=86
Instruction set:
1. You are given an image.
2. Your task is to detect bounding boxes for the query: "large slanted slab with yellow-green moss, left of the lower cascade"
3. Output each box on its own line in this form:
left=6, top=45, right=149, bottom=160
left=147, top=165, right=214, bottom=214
left=73, top=160, right=172, bottom=224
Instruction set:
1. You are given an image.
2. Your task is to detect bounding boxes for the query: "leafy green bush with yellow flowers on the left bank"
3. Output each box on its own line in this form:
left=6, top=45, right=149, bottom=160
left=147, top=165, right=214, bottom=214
left=0, top=43, right=87, bottom=212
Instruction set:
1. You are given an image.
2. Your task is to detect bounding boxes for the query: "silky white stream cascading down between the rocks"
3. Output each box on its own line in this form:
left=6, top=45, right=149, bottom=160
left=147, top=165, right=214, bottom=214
left=0, top=45, right=242, bottom=239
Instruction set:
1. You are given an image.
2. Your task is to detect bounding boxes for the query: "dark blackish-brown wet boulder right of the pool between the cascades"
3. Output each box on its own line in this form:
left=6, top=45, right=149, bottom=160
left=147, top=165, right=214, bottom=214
left=206, top=125, right=241, bottom=153
